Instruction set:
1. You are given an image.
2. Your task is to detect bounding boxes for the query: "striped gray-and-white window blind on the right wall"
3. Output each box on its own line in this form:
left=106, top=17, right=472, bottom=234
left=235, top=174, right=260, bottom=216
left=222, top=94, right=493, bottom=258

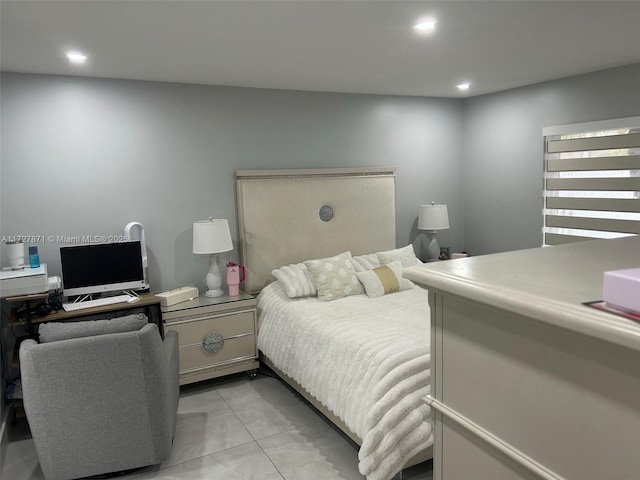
left=543, top=117, right=640, bottom=245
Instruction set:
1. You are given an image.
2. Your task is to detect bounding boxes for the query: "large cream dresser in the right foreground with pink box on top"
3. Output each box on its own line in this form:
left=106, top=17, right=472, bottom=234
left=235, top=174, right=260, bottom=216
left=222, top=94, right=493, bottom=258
left=405, top=236, right=640, bottom=480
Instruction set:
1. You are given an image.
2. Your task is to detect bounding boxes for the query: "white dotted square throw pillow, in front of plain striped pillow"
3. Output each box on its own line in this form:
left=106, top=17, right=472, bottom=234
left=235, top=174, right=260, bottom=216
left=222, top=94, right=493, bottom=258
left=304, top=252, right=364, bottom=302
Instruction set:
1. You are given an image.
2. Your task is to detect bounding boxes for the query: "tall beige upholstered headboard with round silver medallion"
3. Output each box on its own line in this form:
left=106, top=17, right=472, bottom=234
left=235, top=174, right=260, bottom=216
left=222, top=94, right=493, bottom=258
left=236, top=167, right=396, bottom=293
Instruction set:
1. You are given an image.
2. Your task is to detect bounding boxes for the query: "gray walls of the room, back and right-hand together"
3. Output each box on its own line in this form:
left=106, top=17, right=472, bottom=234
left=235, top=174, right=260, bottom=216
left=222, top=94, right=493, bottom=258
left=0, top=64, right=640, bottom=432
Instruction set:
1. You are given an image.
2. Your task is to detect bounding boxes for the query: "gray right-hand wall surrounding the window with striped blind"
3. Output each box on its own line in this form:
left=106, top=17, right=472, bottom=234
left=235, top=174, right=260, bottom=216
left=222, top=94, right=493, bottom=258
left=463, top=64, right=640, bottom=255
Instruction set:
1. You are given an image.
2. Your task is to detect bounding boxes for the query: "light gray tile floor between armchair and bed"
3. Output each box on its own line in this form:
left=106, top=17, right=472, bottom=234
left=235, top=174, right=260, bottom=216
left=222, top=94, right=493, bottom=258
left=2, top=374, right=432, bottom=480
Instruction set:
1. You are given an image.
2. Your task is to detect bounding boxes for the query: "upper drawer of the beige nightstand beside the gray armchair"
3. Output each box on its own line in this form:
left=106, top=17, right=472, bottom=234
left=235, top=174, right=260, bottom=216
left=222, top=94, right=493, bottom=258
left=165, top=311, right=255, bottom=347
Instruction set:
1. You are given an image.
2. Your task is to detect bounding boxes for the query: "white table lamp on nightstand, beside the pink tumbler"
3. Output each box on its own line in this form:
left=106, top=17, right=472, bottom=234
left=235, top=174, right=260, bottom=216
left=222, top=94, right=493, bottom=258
left=193, top=217, right=233, bottom=297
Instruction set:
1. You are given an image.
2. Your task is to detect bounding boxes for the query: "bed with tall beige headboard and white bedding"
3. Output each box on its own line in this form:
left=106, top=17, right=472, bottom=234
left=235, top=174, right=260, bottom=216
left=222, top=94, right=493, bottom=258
left=236, top=168, right=433, bottom=480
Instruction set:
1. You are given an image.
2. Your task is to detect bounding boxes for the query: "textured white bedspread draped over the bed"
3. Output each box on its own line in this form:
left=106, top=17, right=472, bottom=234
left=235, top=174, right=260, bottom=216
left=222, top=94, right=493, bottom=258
left=258, top=282, right=433, bottom=480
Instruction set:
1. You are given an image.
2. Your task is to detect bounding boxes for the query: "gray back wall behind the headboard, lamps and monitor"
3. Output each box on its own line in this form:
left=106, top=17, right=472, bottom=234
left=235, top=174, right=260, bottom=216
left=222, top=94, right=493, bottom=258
left=0, top=73, right=464, bottom=291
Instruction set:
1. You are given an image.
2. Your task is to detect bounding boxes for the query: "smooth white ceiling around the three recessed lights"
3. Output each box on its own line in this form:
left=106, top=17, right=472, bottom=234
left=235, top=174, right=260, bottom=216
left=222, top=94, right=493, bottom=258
left=0, top=0, right=640, bottom=97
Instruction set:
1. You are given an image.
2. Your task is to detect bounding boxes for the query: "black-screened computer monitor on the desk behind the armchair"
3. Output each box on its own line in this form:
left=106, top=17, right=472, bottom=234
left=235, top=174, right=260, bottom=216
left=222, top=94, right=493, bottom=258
left=60, top=241, right=148, bottom=297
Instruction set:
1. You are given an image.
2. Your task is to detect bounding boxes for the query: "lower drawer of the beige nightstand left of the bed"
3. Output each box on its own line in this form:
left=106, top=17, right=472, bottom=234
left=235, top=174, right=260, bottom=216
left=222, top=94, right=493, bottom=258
left=180, top=334, right=256, bottom=371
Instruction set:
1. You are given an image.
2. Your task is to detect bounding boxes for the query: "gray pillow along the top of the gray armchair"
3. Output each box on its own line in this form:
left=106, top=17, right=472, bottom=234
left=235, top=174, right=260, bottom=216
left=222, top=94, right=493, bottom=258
left=38, top=313, right=148, bottom=343
